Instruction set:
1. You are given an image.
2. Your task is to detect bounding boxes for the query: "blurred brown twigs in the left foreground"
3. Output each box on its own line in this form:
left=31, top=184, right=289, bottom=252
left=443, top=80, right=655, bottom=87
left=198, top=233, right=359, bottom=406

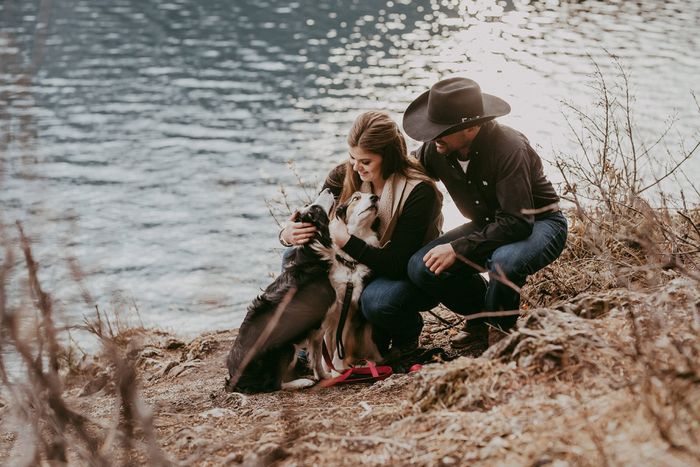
left=0, top=222, right=172, bottom=466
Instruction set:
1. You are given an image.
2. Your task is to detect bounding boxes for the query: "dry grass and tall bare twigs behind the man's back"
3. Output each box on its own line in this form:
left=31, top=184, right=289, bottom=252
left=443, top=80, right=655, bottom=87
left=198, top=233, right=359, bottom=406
left=526, top=57, right=700, bottom=306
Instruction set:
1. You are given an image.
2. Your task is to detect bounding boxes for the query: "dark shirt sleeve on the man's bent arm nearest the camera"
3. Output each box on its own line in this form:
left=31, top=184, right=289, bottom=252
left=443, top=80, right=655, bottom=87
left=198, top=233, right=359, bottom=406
left=451, top=147, right=535, bottom=264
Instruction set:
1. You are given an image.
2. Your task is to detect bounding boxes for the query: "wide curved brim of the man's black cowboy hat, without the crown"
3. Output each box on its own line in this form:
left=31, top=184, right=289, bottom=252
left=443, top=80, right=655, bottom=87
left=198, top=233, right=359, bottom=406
left=403, top=91, right=510, bottom=142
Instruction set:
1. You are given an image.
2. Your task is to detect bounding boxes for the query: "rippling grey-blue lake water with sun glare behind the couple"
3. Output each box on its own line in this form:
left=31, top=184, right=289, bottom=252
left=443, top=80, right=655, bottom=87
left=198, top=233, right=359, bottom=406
left=0, top=0, right=700, bottom=333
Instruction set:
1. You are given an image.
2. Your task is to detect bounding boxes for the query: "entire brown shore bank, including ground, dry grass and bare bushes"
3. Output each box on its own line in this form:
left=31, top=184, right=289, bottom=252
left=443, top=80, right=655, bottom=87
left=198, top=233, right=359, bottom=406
left=0, top=59, right=700, bottom=466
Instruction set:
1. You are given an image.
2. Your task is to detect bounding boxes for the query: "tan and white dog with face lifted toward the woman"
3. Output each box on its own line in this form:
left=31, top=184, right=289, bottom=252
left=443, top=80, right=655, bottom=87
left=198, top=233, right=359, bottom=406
left=310, top=192, right=381, bottom=378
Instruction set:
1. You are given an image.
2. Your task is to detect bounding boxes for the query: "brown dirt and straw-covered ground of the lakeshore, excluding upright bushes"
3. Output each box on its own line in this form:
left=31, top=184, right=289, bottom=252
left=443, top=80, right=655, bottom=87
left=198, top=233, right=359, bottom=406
left=0, top=281, right=700, bottom=466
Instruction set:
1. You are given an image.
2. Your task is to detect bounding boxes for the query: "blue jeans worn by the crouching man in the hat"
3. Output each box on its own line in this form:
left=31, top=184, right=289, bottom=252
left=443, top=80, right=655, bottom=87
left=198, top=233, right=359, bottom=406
left=408, top=212, right=568, bottom=329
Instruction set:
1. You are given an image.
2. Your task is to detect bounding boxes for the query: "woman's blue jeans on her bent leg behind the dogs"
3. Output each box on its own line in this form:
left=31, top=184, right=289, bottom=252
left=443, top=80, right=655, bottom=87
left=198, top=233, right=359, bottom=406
left=282, top=248, right=438, bottom=351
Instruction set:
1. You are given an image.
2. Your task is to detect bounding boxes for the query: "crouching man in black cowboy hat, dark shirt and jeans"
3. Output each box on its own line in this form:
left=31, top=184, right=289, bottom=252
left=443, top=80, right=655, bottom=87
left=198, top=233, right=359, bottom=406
left=403, top=78, right=567, bottom=355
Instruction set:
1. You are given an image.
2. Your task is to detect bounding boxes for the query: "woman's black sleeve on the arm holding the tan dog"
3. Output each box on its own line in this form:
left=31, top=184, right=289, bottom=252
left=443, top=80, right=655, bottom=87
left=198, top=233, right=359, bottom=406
left=343, top=182, right=437, bottom=279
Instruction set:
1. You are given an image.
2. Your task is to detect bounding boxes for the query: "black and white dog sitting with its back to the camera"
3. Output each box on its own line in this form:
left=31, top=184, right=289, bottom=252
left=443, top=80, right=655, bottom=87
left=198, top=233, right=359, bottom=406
left=226, top=189, right=334, bottom=392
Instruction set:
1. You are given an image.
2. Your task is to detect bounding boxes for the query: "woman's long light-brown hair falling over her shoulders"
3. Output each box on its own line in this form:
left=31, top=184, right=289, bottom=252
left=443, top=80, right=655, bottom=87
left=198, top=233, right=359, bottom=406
left=339, top=111, right=437, bottom=203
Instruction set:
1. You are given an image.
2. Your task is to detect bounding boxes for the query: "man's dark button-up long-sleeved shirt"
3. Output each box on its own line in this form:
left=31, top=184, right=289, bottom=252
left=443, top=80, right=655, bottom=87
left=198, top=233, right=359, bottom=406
left=416, top=121, right=559, bottom=264
